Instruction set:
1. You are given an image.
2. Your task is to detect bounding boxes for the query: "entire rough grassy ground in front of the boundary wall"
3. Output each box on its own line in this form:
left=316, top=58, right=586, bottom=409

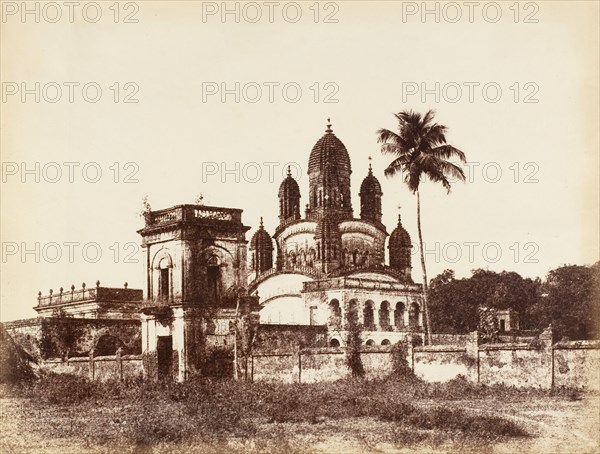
left=0, top=375, right=600, bottom=454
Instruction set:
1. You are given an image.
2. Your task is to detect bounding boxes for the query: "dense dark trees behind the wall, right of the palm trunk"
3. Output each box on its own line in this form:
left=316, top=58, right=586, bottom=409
left=430, top=262, right=600, bottom=339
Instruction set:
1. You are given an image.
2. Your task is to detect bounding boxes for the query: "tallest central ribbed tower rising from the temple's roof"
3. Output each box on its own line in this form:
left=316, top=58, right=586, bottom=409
left=307, top=120, right=353, bottom=221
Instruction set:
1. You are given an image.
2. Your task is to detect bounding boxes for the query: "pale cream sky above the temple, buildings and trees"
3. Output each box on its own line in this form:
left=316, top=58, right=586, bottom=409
left=0, top=1, right=600, bottom=321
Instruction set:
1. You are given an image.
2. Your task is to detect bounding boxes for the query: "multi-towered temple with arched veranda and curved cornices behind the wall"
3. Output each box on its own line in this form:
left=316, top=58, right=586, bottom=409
left=248, top=124, right=423, bottom=345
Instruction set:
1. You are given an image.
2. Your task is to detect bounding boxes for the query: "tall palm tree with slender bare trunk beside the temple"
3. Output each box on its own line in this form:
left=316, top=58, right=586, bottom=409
left=377, top=110, right=466, bottom=344
